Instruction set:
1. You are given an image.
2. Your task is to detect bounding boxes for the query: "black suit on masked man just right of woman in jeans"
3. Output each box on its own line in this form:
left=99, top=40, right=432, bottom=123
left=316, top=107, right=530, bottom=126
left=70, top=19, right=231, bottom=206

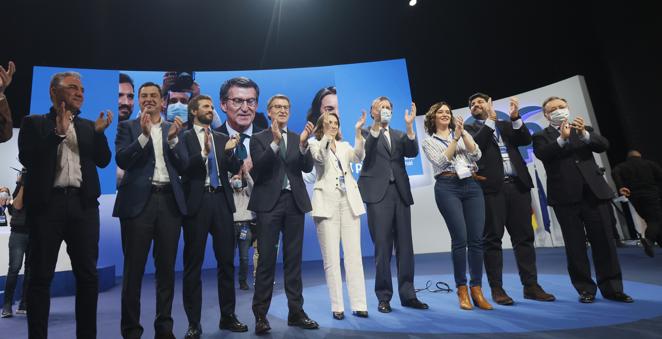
left=466, top=121, right=538, bottom=287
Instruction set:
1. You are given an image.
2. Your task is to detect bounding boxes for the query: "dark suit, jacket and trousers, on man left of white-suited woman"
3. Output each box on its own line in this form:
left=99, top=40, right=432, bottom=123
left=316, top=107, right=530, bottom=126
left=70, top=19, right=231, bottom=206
left=248, top=129, right=313, bottom=318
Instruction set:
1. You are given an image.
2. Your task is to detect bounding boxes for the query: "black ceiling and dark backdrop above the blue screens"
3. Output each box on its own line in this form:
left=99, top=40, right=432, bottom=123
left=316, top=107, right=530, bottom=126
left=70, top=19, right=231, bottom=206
left=0, top=0, right=662, bottom=162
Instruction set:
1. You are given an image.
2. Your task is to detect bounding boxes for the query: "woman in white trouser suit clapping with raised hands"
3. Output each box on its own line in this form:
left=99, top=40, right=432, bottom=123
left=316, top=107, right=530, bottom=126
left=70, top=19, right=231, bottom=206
left=309, top=112, right=368, bottom=320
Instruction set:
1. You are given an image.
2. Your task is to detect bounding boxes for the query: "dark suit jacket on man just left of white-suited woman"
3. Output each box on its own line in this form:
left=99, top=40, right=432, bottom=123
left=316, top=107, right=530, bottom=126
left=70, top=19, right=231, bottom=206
left=248, top=129, right=313, bottom=213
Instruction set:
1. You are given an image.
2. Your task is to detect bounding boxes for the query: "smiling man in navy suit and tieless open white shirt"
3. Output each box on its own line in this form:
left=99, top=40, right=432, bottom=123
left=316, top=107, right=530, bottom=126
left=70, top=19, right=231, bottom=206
left=113, top=82, right=186, bottom=338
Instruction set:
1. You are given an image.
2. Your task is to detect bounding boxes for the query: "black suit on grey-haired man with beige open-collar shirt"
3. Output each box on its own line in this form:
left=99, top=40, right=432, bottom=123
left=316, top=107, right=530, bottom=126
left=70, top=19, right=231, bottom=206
left=18, top=108, right=111, bottom=338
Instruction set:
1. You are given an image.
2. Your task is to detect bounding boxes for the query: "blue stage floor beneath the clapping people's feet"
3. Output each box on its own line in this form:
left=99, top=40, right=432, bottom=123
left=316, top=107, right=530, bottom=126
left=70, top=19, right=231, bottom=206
left=0, top=248, right=662, bottom=339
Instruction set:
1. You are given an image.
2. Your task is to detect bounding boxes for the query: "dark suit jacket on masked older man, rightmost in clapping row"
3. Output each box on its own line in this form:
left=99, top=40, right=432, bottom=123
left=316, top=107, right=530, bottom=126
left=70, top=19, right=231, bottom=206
left=533, top=126, right=614, bottom=206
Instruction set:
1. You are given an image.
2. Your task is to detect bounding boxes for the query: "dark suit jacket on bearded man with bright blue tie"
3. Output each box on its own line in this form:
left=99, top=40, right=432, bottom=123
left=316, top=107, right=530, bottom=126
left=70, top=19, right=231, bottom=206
left=182, top=128, right=241, bottom=215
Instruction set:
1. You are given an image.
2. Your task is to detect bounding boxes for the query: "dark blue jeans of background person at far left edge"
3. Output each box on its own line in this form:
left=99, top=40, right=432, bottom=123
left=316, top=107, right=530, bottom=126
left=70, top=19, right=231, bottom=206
left=3, top=232, right=30, bottom=310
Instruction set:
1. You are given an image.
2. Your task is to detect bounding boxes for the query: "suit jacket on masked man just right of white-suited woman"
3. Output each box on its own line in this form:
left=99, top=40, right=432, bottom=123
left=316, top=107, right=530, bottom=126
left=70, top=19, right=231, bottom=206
left=358, top=128, right=418, bottom=205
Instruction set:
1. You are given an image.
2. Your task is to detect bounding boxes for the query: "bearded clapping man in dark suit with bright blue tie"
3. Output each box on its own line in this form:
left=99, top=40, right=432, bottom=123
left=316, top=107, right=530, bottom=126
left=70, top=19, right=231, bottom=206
left=182, top=95, right=248, bottom=339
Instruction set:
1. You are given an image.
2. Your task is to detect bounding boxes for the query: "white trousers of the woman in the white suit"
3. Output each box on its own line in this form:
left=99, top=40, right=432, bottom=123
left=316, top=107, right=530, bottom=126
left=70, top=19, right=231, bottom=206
left=314, top=190, right=368, bottom=312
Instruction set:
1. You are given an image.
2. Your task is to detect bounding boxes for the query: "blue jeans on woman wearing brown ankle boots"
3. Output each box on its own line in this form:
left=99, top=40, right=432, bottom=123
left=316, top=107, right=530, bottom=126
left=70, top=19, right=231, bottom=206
left=434, top=176, right=485, bottom=286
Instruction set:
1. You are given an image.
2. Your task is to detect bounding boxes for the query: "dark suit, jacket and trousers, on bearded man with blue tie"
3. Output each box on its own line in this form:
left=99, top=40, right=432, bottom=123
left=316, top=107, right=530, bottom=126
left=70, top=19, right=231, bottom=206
left=182, top=127, right=240, bottom=328
